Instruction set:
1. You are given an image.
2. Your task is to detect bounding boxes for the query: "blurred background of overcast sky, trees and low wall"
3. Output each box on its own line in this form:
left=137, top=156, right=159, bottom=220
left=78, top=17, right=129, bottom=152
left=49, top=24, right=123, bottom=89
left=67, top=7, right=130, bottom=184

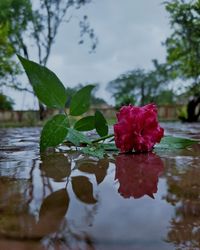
left=0, top=0, right=200, bottom=126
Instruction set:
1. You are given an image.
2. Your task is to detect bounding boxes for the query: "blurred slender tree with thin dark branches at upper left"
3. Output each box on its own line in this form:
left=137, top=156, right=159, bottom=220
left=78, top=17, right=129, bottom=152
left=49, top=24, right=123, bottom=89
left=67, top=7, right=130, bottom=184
left=0, top=0, right=98, bottom=118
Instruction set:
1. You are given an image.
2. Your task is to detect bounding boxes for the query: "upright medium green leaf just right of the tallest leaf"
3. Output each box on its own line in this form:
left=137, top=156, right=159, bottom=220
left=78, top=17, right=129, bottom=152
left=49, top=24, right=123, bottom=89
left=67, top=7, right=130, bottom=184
left=70, top=85, right=95, bottom=116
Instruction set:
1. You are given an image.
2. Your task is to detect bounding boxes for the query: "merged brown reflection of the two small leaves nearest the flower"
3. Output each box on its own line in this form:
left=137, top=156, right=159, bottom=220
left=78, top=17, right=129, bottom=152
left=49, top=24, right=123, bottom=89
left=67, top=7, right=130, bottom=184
left=78, top=159, right=109, bottom=184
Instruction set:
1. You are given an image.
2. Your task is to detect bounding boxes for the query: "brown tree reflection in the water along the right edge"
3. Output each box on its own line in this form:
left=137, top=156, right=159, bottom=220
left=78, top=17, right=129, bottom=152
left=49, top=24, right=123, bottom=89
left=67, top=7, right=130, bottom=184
left=165, top=155, right=200, bottom=249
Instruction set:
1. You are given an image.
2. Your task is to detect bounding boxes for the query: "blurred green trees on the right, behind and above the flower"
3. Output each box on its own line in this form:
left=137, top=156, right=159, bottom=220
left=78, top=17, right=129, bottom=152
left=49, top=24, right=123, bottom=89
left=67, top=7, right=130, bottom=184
left=108, top=0, right=200, bottom=122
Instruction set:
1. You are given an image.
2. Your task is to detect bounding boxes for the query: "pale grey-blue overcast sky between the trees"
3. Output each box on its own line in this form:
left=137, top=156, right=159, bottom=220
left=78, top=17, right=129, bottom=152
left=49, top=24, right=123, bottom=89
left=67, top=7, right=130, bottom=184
left=4, top=0, right=170, bottom=109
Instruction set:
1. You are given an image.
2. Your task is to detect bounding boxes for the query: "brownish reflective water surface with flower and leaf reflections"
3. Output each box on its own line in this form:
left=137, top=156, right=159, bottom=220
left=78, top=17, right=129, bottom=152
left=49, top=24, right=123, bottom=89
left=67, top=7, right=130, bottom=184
left=0, top=123, right=200, bottom=250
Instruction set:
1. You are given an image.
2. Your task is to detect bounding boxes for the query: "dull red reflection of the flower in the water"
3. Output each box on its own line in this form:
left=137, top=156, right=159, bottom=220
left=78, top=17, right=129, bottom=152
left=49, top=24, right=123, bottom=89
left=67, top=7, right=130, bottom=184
left=115, top=153, right=164, bottom=198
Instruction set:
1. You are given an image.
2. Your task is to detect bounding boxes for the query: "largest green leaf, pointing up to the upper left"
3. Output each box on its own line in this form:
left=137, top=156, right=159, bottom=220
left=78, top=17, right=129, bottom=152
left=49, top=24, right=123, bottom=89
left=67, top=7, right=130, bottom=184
left=18, top=55, right=67, bottom=108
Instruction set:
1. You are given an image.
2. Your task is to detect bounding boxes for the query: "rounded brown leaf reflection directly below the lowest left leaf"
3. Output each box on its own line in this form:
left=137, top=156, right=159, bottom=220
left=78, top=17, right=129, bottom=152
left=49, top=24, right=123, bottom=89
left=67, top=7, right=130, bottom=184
left=40, top=153, right=71, bottom=182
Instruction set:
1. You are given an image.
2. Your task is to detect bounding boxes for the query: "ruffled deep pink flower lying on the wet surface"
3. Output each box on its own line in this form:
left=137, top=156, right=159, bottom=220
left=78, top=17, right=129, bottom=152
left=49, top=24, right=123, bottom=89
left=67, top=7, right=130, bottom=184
left=114, top=104, right=164, bottom=153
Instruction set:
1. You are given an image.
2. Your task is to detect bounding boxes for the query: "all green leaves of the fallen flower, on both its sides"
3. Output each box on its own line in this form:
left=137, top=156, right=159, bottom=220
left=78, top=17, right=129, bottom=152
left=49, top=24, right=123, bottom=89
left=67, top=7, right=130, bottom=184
left=19, top=56, right=197, bottom=155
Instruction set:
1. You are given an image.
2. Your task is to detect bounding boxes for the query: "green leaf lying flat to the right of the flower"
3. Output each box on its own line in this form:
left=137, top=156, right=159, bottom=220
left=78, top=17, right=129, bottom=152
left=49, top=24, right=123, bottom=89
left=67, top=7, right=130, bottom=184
left=155, top=136, right=199, bottom=149
